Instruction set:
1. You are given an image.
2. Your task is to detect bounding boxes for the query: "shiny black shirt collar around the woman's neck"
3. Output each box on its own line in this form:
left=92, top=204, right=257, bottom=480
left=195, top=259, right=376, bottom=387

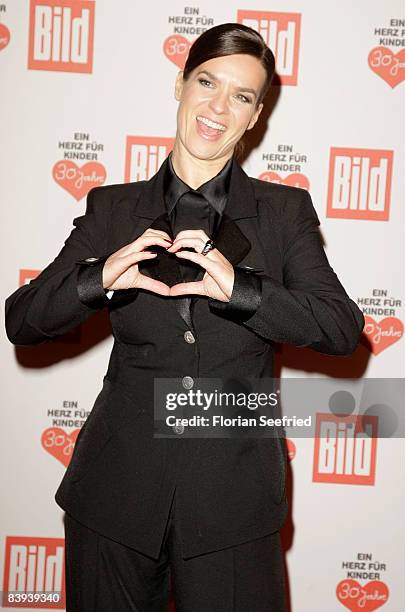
left=164, top=154, right=233, bottom=214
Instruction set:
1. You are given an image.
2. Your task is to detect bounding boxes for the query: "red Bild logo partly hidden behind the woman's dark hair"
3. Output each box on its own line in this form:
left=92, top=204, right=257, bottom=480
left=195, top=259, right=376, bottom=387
left=237, top=10, right=301, bottom=85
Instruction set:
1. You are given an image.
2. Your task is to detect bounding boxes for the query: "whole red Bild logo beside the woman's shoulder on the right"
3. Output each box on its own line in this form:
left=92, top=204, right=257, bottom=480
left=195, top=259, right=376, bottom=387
left=326, top=147, right=393, bottom=221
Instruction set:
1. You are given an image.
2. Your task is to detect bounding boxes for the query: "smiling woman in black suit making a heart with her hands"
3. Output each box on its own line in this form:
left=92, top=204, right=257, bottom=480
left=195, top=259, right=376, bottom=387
left=6, top=24, right=364, bottom=612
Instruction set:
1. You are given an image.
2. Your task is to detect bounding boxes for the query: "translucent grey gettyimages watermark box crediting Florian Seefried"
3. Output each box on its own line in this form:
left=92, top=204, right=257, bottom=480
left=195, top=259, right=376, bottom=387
left=154, top=376, right=405, bottom=441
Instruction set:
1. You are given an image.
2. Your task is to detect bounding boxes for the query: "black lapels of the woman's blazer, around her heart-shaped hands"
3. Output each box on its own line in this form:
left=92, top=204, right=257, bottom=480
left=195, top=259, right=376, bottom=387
left=133, top=159, right=257, bottom=329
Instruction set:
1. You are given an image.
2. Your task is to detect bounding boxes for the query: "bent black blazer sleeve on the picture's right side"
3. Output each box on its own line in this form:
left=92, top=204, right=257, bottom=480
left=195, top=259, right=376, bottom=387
left=209, top=190, right=364, bottom=355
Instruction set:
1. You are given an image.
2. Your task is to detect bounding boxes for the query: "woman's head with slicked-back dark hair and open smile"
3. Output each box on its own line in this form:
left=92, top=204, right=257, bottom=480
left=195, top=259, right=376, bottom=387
left=173, top=24, right=275, bottom=179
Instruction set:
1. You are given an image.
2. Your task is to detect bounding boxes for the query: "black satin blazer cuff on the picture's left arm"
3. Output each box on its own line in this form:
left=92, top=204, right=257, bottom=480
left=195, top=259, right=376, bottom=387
left=76, top=255, right=109, bottom=310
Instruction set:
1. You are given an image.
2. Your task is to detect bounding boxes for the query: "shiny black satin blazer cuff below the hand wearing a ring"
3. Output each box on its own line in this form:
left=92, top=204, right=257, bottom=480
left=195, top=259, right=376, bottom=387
left=208, top=266, right=262, bottom=323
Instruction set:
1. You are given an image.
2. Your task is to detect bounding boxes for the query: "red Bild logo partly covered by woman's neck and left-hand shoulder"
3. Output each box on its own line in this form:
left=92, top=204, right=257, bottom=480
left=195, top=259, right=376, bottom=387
left=124, top=136, right=174, bottom=183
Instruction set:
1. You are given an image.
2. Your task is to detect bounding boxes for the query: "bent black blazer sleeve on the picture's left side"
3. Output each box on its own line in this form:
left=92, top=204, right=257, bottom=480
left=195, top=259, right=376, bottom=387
left=5, top=187, right=111, bottom=345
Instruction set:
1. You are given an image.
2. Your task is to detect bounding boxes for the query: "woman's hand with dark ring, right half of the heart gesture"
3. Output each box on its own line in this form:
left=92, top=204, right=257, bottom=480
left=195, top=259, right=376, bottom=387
left=167, top=230, right=235, bottom=302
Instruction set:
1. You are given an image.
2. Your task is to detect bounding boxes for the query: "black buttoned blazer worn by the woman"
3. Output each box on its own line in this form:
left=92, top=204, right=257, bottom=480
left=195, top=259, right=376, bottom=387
left=6, top=161, right=364, bottom=557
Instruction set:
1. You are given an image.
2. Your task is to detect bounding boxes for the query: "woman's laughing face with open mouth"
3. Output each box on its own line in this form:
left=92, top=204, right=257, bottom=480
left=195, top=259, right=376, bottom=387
left=175, top=54, right=266, bottom=160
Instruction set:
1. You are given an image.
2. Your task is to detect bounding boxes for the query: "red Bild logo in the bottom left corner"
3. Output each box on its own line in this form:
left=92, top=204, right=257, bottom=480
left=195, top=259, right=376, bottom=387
left=2, top=536, right=65, bottom=609
